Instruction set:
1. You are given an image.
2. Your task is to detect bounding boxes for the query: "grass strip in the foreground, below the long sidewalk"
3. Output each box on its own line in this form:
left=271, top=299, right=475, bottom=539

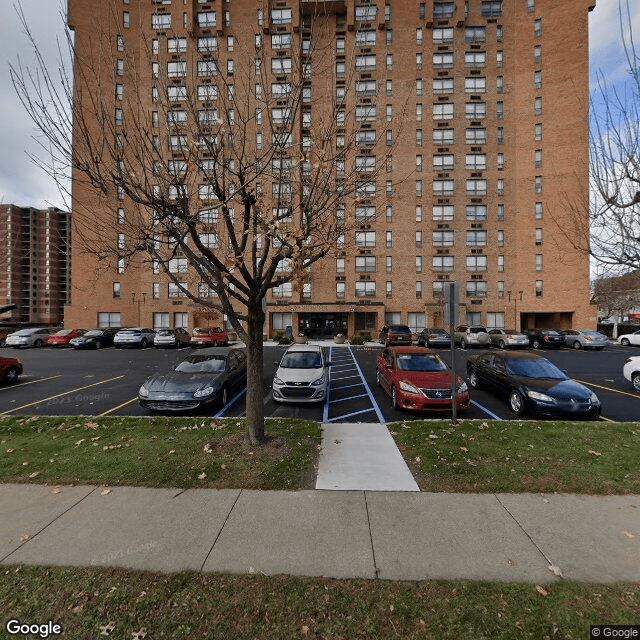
left=0, top=566, right=640, bottom=640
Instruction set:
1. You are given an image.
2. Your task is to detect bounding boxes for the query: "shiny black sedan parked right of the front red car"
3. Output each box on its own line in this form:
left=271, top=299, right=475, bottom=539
left=467, top=351, right=602, bottom=419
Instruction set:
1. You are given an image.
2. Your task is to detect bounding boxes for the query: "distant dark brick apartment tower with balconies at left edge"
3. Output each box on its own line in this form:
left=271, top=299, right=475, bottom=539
left=0, top=204, right=70, bottom=325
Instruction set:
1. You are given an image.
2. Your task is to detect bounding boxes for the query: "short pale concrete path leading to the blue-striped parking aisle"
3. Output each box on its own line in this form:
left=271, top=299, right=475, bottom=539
left=316, top=423, right=420, bottom=491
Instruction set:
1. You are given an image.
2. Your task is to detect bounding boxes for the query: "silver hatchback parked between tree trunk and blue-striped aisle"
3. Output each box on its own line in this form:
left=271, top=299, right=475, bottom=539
left=272, top=344, right=331, bottom=402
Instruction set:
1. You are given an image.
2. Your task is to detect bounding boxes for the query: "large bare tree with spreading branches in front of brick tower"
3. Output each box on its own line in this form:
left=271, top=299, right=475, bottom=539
left=11, top=3, right=400, bottom=444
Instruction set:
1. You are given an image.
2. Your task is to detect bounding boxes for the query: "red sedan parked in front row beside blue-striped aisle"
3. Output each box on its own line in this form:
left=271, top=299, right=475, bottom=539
left=376, top=347, right=469, bottom=411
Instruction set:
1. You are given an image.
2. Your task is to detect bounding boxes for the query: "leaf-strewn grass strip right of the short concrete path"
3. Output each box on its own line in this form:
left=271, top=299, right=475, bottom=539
left=389, top=420, right=640, bottom=495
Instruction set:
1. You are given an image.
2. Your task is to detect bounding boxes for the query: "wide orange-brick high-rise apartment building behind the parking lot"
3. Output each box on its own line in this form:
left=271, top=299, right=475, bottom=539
left=65, top=0, right=596, bottom=335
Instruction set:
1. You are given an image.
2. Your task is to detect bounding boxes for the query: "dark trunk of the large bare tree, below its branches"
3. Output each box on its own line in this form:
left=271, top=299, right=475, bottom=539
left=246, top=300, right=266, bottom=445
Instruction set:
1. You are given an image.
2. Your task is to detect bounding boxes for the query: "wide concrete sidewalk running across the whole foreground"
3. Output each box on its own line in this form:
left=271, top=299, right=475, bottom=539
left=0, top=484, right=640, bottom=583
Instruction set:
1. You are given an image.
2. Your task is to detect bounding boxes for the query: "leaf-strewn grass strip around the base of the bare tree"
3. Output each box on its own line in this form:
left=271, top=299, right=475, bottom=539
left=0, top=416, right=321, bottom=489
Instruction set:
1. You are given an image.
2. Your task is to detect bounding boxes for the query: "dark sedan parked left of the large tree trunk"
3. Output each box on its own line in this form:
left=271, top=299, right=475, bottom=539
left=138, top=347, right=247, bottom=412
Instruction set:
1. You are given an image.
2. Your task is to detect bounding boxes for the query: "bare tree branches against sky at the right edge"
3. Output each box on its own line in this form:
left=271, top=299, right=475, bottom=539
left=576, top=0, right=640, bottom=271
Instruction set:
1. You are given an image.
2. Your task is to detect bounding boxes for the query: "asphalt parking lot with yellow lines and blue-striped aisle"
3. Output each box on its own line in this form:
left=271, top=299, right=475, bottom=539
left=0, top=343, right=640, bottom=422
